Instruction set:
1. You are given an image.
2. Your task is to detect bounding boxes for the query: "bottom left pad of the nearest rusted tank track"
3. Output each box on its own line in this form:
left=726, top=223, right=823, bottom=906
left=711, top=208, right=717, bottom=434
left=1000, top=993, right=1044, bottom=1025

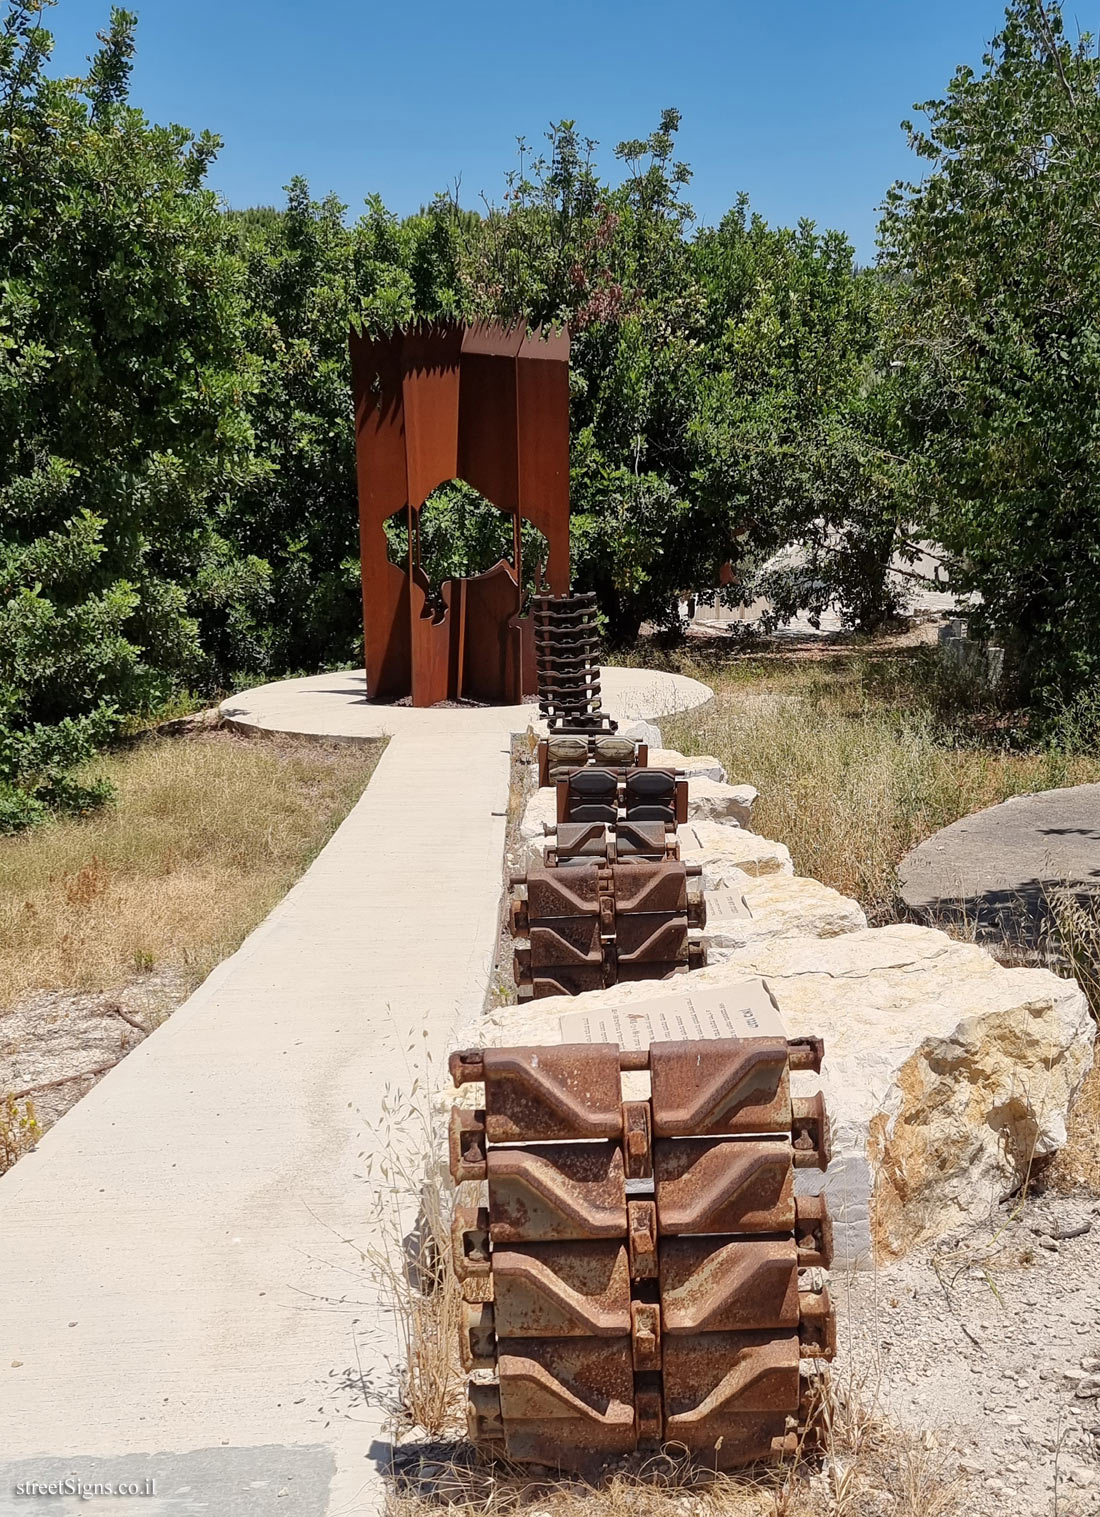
left=498, top=1336, right=634, bottom=1468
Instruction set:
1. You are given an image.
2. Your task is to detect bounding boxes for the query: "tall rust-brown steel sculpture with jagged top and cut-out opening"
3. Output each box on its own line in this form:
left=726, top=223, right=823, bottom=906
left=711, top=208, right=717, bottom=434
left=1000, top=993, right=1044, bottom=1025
left=350, top=323, right=569, bottom=705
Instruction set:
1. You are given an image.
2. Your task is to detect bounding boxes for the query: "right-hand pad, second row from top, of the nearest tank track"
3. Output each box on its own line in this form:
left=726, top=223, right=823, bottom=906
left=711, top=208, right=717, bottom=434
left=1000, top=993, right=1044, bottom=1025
left=652, top=1138, right=795, bottom=1236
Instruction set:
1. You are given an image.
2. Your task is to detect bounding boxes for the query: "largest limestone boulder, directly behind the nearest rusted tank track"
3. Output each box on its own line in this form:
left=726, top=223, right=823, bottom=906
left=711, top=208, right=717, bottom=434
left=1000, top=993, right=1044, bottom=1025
left=473, top=924, right=1095, bottom=1267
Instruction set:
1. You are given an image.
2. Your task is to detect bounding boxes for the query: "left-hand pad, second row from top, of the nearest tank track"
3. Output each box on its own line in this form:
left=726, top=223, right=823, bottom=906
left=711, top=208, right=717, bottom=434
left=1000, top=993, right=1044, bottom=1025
left=489, top=1142, right=627, bottom=1245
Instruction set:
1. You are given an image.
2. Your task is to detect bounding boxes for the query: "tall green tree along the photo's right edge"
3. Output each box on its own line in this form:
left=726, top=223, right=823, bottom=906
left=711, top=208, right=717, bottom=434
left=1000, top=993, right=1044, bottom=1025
left=880, top=0, right=1100, bottom=718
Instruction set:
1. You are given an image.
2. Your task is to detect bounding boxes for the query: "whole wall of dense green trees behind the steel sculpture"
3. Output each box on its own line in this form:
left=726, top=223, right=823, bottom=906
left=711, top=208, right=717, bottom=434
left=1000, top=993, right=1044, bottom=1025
left=0, top=0, right=1100, bottom=830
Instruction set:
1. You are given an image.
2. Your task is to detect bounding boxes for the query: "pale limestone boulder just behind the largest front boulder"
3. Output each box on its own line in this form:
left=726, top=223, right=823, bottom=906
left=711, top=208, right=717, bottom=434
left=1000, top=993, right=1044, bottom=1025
left=702, top=874, right=866, bottom=963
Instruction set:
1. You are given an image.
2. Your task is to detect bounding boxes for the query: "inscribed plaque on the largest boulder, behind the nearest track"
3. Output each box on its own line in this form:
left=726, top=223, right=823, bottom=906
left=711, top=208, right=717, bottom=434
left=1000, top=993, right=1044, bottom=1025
left=560, top=980, right=786, bottom=1048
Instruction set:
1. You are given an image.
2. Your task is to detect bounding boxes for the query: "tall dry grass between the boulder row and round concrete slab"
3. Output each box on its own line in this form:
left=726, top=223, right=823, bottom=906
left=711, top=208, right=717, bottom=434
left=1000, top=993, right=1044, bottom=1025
left=643, top=654, right=1100, bottom=921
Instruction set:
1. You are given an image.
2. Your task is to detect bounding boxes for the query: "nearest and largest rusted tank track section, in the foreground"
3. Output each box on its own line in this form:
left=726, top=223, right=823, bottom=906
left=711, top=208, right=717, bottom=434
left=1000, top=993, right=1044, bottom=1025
left=451, top=1038, right=836, bottom=1473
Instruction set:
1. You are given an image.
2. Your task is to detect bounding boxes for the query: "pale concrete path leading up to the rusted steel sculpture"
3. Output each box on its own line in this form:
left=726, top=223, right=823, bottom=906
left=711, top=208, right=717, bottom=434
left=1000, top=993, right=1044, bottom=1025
left=0, top=671, right=710, bottom=1517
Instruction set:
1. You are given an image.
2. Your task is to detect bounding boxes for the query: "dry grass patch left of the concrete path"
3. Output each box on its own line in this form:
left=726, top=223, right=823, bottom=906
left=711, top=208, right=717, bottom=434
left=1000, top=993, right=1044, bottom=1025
left=0, top=731, right=381, bottom=1006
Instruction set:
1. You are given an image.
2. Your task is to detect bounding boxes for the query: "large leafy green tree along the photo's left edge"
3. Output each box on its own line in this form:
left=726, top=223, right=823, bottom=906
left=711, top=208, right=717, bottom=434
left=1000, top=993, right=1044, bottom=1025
left=0, top=0, right=256, bottom=827
